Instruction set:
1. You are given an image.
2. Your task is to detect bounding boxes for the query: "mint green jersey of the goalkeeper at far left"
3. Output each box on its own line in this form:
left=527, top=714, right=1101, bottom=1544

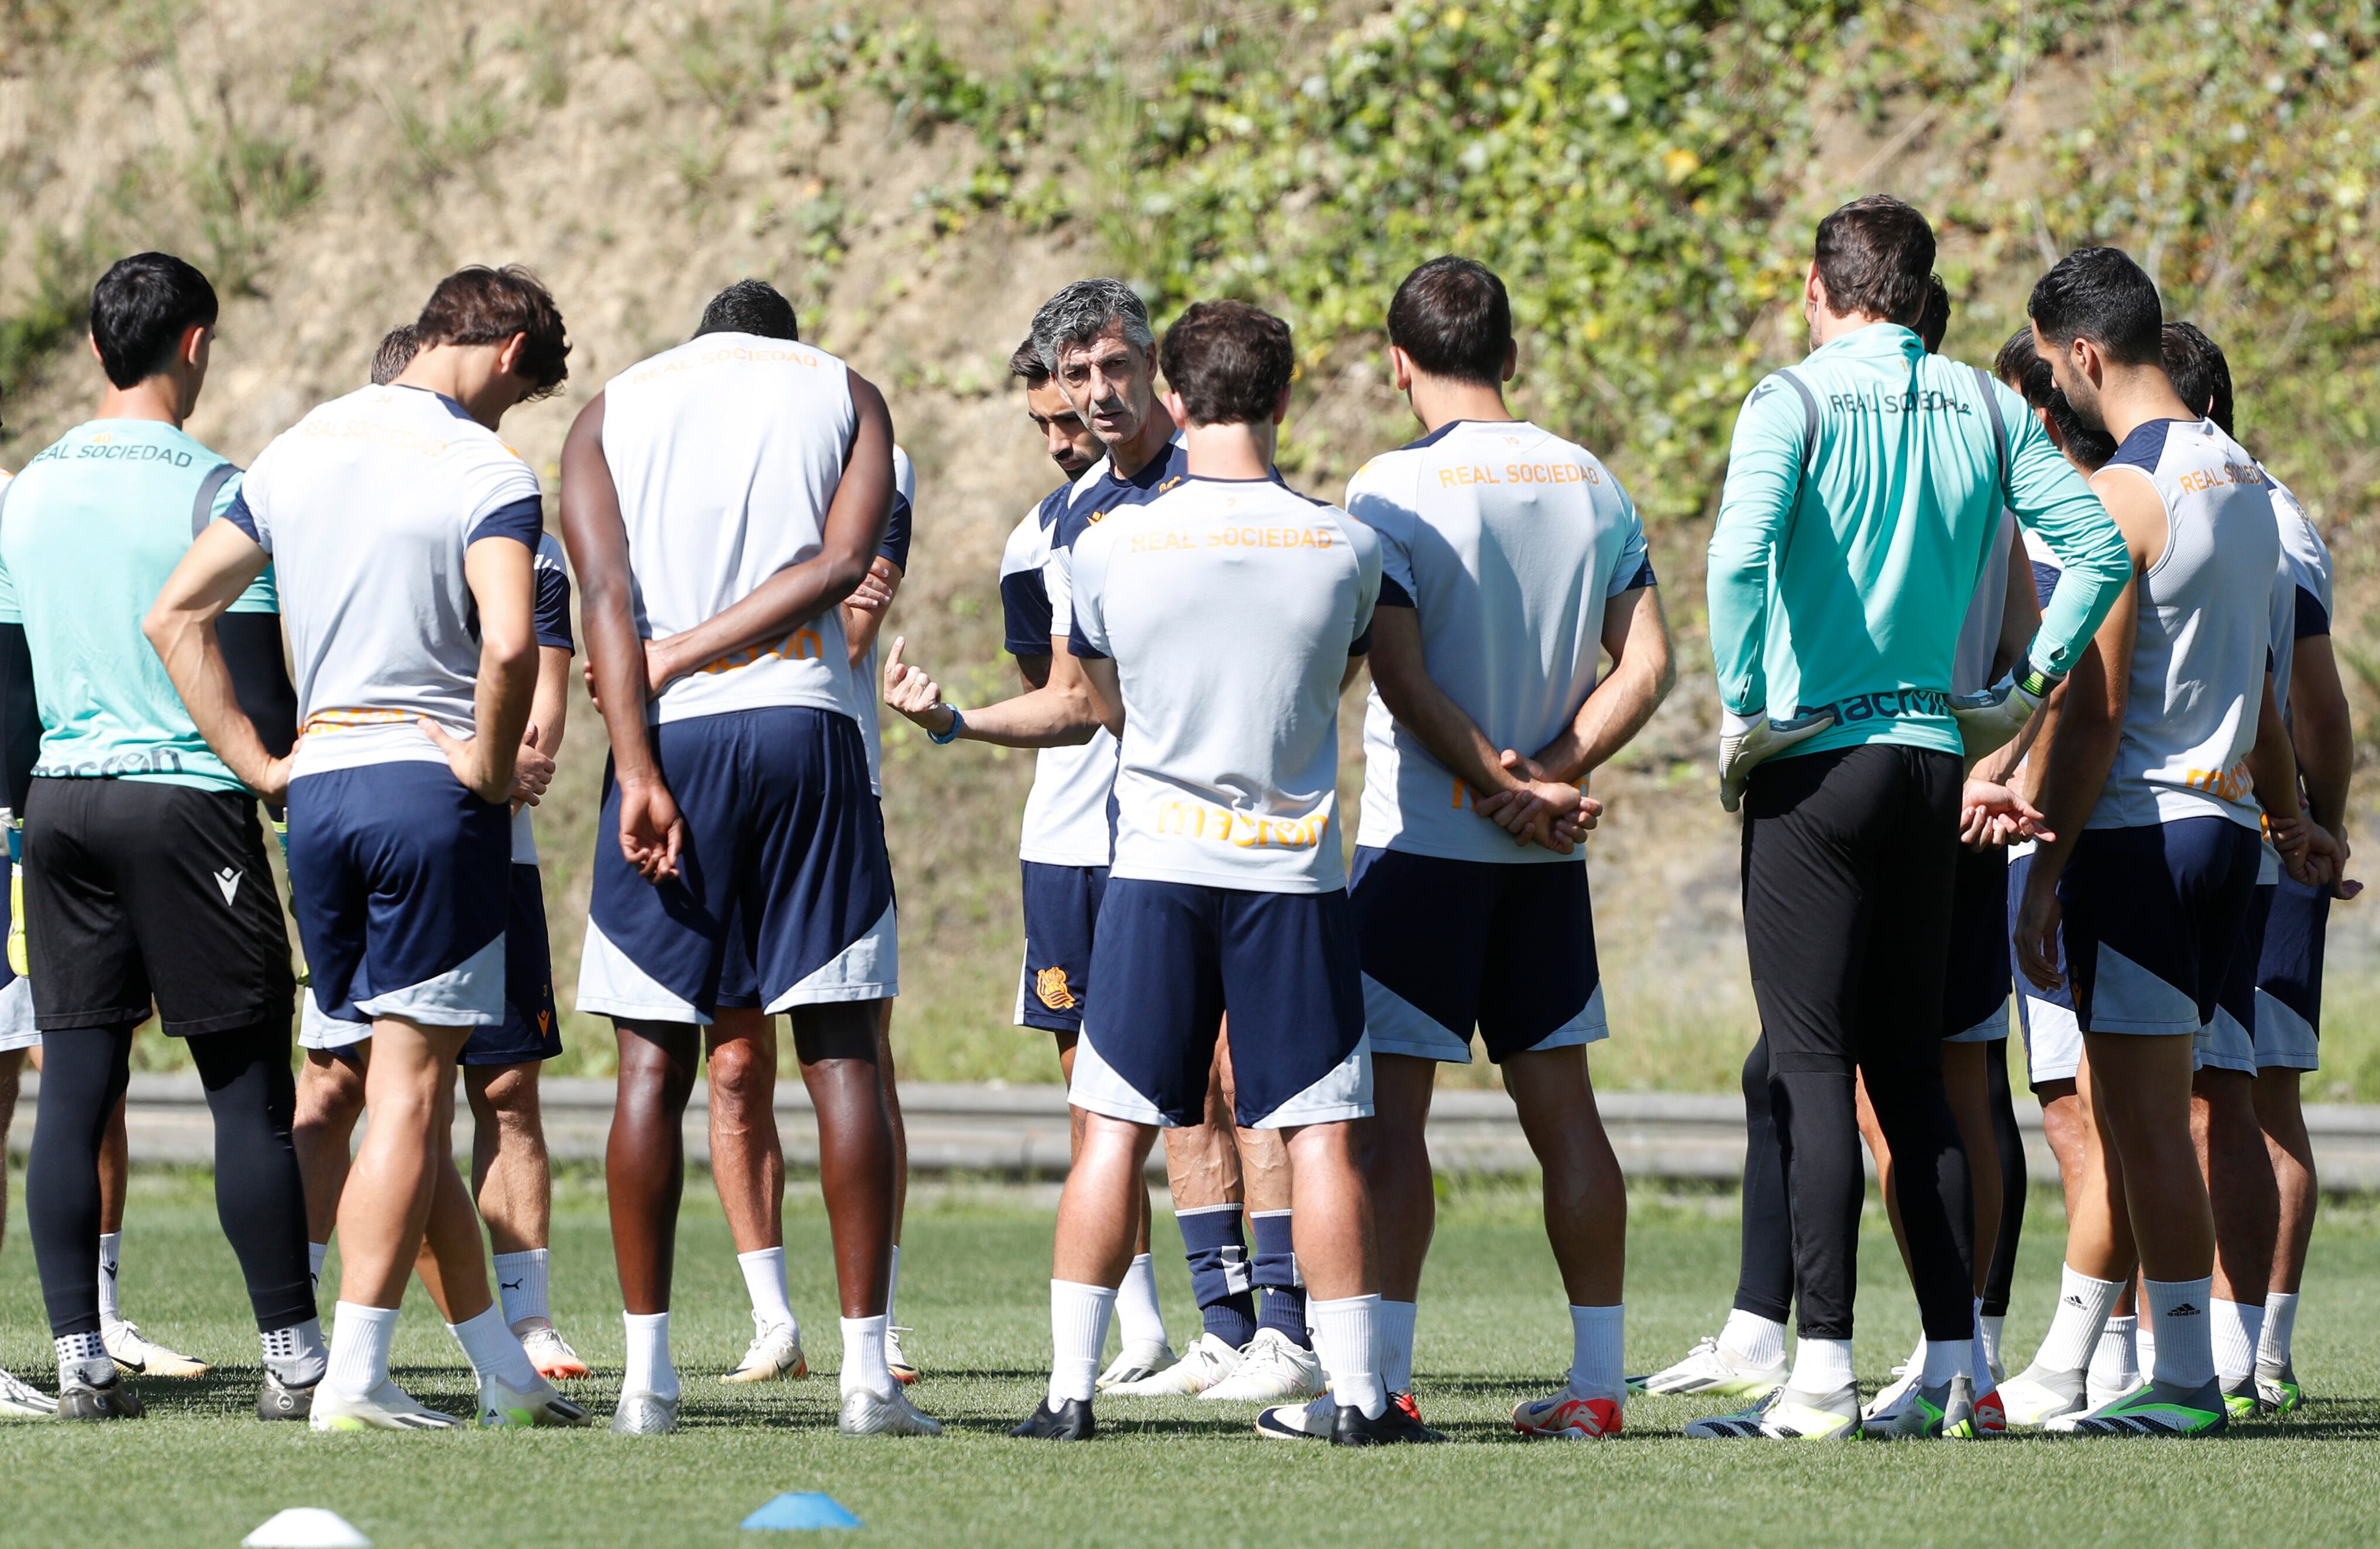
left=0, top=419, right=281, bottom=790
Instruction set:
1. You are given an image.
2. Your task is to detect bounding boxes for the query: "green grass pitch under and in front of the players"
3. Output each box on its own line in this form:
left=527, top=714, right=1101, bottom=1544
left=0, top=1175, right=2380, bottom=1549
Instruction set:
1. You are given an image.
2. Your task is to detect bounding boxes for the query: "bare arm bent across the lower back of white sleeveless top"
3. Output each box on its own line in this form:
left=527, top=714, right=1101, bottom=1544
left=645, top=374, right=893, bottom=690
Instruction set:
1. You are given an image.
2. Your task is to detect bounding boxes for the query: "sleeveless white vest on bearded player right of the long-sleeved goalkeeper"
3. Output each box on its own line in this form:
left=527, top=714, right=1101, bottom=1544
left=2085, top=419, right=2297, bottom=831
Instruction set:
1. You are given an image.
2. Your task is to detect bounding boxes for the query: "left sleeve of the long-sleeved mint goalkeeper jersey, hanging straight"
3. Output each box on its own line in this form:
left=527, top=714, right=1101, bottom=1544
left=1709, top=376, right=1807, bottom=716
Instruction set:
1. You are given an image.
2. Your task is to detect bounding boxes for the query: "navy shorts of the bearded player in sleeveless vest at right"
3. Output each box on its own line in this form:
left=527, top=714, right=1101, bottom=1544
left=2059, top=816, right=2264, bottom=1037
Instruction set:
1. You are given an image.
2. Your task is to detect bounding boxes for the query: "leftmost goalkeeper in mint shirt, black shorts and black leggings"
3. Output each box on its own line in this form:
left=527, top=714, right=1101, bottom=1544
left=0, top=252, right=324, bottom=1420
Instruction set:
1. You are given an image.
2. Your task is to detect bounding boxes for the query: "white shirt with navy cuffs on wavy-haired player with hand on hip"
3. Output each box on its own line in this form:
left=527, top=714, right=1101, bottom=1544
left=223, top=385, right=545, bottom=776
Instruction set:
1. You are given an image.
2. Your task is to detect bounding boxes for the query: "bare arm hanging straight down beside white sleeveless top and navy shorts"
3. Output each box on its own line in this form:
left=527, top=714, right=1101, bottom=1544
left=562, top=393, right=686, bottom=883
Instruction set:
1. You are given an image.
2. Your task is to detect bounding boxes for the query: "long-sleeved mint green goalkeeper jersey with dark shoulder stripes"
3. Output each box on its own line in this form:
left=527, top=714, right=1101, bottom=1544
left=1709, top=323, right=2133, bottom=756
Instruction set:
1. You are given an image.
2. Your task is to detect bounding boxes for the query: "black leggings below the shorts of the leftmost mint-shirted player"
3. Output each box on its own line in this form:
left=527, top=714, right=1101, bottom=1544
left=24, top=1018, right=314, bottom=1335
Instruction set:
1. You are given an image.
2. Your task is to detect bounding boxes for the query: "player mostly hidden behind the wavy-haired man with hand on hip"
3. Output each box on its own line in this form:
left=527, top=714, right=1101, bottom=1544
left=293, top=323, right=588, bottom=1380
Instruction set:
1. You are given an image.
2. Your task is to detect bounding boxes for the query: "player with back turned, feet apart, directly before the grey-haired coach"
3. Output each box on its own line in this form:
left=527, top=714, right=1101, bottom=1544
left=1012, top=302, right=1437, bottom=1444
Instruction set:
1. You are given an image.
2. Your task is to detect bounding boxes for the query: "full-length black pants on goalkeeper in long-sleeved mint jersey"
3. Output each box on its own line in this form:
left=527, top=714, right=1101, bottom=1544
left=1742, top=742, right=1975, bottom=1340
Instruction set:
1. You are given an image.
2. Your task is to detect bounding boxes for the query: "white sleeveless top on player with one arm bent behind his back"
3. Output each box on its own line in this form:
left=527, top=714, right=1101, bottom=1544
left=602, top=333, right=859, bottom=721
